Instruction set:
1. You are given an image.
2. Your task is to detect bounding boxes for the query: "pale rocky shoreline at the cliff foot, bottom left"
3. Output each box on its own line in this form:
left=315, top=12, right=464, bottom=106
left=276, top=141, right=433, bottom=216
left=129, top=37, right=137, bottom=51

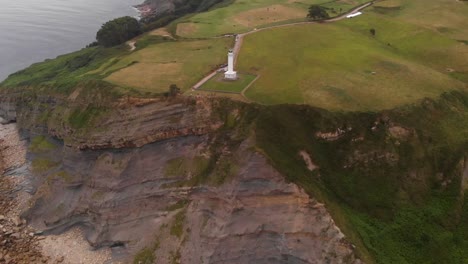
left=0, top=123, right=111, bottom=264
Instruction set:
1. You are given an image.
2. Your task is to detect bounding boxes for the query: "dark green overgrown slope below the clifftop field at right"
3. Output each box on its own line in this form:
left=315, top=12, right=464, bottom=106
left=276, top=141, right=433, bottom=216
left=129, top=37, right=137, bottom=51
left=255, top=90, right=468, bottom=263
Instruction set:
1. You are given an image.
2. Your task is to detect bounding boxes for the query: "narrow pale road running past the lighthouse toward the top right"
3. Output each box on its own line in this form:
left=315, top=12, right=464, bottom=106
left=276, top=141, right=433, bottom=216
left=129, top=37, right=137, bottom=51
left=192, top=0, right=376, bottom=89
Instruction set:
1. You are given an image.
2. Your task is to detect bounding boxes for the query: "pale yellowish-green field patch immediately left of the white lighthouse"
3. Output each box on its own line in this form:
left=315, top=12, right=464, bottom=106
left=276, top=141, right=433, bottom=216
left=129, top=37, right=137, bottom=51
left=103, top=39, right=232, bottom=93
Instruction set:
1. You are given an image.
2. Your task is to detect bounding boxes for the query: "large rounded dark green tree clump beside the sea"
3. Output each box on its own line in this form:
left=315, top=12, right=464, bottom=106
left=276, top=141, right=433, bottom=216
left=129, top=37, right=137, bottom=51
left=96, top=16, right=141, bottom=47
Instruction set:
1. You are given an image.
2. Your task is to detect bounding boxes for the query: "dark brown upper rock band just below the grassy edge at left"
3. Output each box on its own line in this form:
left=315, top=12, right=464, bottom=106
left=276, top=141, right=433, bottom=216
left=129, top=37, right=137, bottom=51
left=0, top=89, right=222, bottom=150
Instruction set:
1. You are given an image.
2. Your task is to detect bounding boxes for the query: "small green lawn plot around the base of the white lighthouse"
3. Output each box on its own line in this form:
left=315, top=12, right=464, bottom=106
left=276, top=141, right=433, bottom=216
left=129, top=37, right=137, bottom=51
left=199, top=73, right=257, bottom=93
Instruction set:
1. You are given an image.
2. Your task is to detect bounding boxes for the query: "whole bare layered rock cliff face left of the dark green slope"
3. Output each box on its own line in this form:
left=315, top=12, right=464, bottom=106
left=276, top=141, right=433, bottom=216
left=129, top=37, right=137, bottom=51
left=0, top=90, right=360, bottom=263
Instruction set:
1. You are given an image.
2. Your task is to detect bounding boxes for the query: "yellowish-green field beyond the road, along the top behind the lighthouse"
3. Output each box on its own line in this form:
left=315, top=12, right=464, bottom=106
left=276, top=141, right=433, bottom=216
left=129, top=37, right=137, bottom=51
left=175, top=0, right=366, bottom=37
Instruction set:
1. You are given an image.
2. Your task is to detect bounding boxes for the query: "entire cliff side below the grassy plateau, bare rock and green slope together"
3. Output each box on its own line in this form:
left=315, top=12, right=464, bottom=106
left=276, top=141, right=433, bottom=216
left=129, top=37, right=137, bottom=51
left=0, top=88, right=468, bottom=263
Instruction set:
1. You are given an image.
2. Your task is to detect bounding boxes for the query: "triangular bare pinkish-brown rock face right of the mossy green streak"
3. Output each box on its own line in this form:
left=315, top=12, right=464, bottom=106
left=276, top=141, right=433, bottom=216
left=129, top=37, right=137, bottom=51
left=181, top=153, right=359, bottom=263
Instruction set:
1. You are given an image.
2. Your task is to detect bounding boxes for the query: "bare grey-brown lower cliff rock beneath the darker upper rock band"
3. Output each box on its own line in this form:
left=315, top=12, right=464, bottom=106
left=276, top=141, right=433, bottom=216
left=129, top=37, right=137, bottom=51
left=17, top=136, right=360, bottom=263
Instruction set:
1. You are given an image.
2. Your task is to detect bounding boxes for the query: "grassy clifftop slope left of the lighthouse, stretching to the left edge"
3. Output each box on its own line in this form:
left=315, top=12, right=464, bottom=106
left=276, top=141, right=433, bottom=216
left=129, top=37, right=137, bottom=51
left=0, top=35, right=233, bottom=94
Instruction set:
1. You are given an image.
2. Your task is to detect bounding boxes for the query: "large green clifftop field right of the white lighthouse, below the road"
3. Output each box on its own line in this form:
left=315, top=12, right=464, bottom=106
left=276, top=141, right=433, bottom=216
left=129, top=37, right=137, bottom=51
left=238, top=9, right=468, bottom=110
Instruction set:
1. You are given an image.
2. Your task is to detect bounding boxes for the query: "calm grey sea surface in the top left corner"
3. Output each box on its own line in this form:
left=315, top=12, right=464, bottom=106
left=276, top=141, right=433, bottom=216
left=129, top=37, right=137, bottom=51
left=0, top=0, right=143, bottom=81
